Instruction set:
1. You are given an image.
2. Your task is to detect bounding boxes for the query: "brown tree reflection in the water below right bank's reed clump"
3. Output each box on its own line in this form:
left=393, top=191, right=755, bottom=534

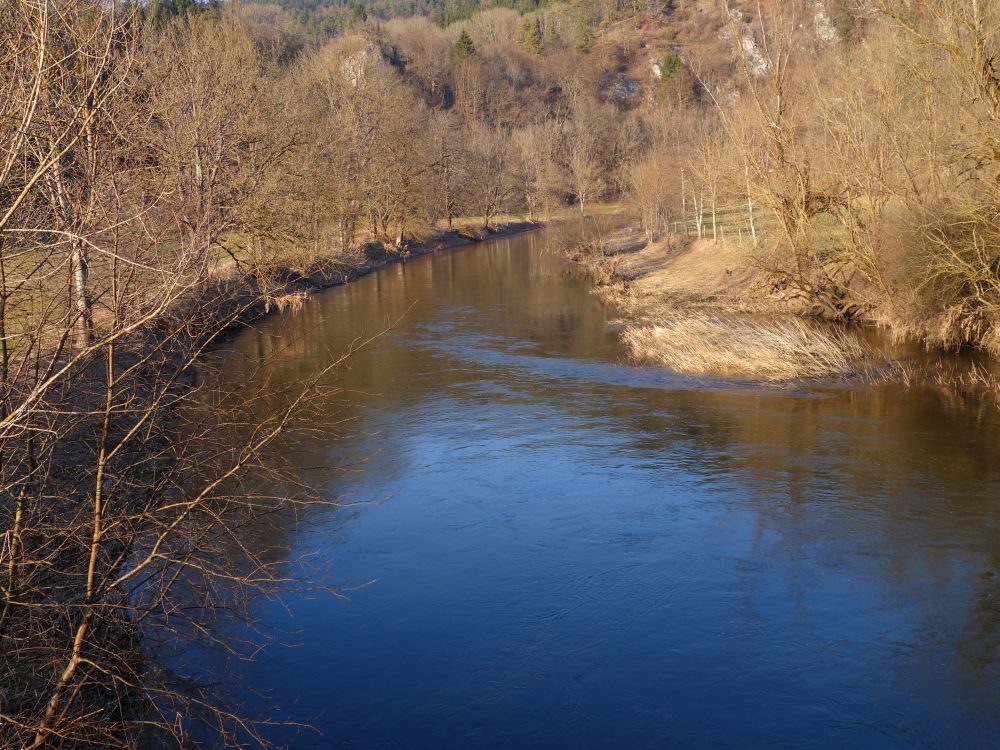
left=620, top=388, right=1000, bottom=688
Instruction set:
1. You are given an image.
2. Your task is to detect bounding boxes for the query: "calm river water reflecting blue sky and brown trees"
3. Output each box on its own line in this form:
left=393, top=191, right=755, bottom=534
left=203, top=229, right=1000, bottom=748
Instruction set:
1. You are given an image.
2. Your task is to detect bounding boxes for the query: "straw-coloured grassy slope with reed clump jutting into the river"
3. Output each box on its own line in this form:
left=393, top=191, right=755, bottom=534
left=570, top=223, right=878, bottom=381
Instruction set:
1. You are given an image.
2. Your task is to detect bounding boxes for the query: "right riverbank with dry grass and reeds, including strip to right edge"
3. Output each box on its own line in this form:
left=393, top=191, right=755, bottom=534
left=567, top=226, right=1000, bottom=395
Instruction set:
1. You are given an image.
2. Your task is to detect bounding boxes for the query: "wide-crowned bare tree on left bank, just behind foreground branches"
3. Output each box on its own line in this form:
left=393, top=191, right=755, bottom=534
left=144, top=21, right=298, bottom=280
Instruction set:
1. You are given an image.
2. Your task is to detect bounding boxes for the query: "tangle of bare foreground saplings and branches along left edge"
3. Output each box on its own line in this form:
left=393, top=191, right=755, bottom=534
left=0, top=5, right=358, bottom=748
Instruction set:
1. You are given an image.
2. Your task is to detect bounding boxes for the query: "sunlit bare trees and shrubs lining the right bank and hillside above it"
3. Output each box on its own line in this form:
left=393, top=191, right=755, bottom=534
left=620, top=0, right=1000, bottom=374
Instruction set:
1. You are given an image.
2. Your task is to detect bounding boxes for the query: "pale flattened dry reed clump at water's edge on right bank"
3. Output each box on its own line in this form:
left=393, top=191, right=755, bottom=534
left=622, top=313, right=873, bottom=381
